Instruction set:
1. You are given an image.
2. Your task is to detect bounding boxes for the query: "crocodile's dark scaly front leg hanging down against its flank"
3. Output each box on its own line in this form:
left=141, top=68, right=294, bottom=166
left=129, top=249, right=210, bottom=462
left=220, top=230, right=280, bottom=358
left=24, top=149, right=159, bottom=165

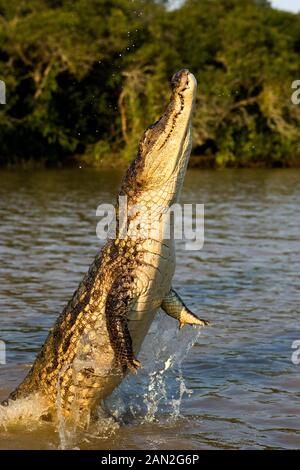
left=105, top=280, right=141, bottom=373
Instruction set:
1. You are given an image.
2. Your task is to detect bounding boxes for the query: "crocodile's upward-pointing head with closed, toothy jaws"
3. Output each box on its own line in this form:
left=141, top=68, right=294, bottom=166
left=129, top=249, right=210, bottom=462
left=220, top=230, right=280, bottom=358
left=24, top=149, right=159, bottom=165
left=121, top=69, right=197, bottom=202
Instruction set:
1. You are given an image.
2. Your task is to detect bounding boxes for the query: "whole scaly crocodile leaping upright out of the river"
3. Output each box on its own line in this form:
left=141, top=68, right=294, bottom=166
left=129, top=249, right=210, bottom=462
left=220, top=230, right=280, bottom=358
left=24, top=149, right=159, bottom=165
left=3, top=69, right=208, bottom=426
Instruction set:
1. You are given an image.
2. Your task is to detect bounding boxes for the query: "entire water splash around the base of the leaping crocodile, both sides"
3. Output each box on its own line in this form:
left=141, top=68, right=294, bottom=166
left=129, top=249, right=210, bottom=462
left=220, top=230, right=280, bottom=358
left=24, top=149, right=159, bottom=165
left=0, top=313, right=200, bottom=449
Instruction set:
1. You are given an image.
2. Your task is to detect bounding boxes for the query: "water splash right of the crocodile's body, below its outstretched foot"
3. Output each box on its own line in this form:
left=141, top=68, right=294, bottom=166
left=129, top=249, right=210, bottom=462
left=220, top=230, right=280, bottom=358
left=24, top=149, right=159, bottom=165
left=105, top=313, right=201, bottom=423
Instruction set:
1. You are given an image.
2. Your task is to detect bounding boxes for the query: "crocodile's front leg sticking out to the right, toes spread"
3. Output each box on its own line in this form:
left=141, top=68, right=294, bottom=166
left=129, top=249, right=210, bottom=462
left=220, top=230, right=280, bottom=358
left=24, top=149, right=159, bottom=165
left=161, top=289, right=210, bottom=329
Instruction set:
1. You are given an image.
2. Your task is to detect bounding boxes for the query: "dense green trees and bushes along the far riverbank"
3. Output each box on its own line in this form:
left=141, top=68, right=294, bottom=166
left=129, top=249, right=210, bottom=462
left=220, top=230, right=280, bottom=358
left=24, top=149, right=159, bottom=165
left=0, top=0, right=300, bottom=167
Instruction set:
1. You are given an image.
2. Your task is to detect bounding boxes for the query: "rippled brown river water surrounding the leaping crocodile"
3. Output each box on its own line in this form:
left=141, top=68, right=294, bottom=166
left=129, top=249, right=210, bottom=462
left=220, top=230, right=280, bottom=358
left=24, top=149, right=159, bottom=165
left=0, top=170, right=300, bottom=449
